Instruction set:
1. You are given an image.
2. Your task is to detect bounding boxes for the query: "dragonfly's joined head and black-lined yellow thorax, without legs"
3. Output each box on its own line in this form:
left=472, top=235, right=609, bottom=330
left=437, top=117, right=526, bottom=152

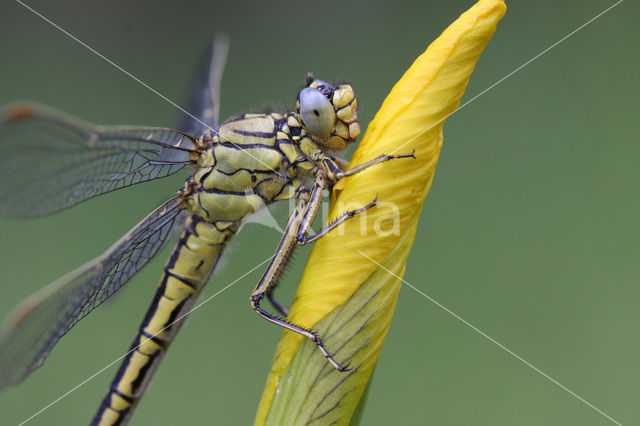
left=183, top=75, right=360, bottom=230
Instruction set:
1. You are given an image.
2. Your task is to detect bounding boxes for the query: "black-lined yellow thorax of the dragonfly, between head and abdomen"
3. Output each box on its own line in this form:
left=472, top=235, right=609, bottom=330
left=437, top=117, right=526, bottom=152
left=183, top=113, right=306, bottom=227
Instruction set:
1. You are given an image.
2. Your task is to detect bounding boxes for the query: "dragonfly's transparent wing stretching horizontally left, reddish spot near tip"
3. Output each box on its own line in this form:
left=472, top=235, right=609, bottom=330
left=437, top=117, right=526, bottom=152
left=0, top=104, right=196, bottom=218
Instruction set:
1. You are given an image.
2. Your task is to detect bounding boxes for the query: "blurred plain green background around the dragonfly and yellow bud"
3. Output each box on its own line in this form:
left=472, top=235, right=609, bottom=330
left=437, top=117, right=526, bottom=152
left=0, top=0, right=640, bottom=425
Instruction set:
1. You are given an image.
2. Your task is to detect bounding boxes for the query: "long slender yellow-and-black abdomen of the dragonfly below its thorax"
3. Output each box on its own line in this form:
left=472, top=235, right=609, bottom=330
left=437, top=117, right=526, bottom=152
left=92, top=216, right=232, bottom=425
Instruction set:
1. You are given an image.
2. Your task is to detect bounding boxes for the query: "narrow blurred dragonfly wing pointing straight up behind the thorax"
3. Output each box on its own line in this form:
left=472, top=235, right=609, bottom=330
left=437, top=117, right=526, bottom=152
left=177, top=34, right=229, bottom=135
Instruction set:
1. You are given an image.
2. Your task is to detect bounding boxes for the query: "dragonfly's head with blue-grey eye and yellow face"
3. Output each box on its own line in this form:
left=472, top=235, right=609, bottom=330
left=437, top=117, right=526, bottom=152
left=296, top=73, right=360, bottom=151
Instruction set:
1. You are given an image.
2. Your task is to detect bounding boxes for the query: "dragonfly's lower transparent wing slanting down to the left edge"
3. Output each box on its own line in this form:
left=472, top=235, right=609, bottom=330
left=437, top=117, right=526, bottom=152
left=0, top=197, right=182, bottom=389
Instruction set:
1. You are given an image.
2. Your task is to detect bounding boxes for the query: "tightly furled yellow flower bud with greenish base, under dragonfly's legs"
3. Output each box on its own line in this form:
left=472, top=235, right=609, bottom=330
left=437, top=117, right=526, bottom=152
left=255, top=0, right=506, bottom=425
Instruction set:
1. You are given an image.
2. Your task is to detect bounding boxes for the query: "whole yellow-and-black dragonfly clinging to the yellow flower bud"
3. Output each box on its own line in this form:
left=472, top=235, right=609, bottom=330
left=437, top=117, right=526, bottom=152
left=0, top=37, right=413, bottom=425
